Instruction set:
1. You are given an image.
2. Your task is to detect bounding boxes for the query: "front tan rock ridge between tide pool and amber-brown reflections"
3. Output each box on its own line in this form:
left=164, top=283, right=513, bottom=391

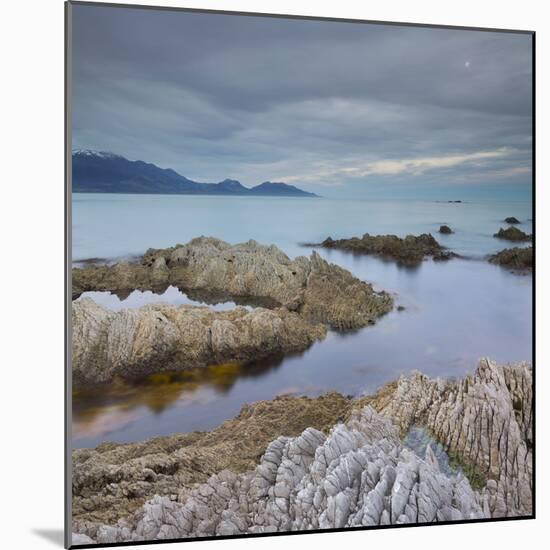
left=72, top=298, right=326, bottom=386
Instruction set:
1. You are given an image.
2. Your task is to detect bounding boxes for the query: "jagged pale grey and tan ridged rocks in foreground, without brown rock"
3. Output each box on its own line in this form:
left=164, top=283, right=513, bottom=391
left=74, top=359, right=532, bottom=542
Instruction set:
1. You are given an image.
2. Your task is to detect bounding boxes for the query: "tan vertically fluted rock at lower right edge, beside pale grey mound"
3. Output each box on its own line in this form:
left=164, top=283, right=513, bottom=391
left=366, top=359, right=533, bottom=517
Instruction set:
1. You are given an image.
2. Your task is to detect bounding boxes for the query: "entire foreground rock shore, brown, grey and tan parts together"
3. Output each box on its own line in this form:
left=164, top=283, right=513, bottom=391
left=73, top=360, right=532, bottom=543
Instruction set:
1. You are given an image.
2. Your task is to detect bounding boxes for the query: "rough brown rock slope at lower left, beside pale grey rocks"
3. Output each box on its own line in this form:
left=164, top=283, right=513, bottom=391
left=72, top=392, right=350, bottom=523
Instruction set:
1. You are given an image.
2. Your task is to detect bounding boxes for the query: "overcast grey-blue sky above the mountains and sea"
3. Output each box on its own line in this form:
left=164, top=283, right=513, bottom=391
left=72, top=5, right=532, bottom=199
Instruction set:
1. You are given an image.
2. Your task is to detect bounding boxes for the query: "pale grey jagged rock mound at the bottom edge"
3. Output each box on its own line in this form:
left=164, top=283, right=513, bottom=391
left=74, top=406, right=487, bottom=543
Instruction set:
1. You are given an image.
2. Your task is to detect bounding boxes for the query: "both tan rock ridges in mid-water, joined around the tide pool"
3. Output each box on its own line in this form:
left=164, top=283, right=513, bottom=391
left=72, top=237, right=393, bottom=386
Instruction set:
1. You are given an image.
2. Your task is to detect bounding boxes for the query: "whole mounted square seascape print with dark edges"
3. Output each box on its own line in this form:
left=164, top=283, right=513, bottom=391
left=66, top=2, right=534, bottom=547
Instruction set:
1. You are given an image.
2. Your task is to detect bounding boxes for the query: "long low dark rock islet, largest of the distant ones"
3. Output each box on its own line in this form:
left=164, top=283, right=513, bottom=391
left=318, top=233, right=456, bottom=266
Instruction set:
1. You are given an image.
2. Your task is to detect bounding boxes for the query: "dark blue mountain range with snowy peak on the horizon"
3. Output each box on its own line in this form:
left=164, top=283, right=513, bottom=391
left=72, top=149, right=318, bottom=197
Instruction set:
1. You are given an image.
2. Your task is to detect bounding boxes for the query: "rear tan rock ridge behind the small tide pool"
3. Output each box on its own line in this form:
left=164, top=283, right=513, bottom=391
left=72, top=237, right=393, bottom=330
